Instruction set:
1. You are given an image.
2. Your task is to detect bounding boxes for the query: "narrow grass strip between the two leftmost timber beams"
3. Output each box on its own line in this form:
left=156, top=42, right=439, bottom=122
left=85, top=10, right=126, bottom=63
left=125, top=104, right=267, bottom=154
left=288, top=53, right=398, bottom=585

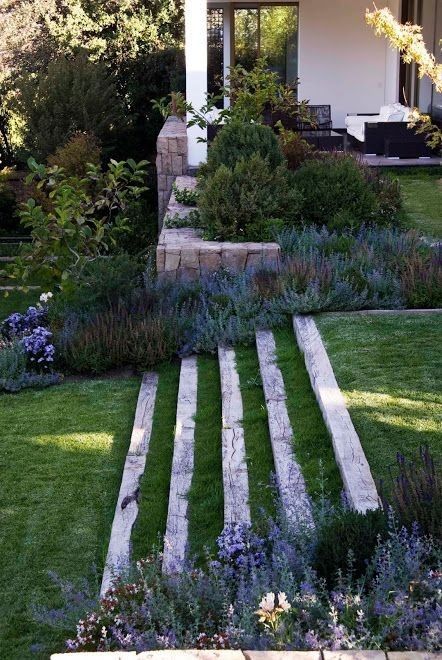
left=132, top=363, right=180, bottom=559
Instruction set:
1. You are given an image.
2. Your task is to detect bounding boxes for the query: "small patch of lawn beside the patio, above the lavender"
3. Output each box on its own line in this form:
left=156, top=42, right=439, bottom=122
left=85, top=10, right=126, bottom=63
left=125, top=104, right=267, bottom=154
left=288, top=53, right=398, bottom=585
left=394, top=167, right=442, bottom=239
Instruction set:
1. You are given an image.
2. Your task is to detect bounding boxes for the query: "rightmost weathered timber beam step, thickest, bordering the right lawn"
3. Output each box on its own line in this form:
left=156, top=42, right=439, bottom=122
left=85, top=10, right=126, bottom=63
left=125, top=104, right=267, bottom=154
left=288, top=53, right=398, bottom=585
left=293, top=316, right=379, bottom=513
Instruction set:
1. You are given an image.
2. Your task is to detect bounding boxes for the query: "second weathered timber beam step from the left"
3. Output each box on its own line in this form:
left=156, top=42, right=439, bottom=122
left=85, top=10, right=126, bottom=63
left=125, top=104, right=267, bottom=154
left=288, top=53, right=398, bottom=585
left=163, top=356, right=198, bottom=574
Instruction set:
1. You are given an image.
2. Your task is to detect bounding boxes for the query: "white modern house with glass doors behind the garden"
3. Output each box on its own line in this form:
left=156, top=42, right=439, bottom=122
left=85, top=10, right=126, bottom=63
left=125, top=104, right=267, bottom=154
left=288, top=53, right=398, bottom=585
left=185, top=0, right=442, bottom=167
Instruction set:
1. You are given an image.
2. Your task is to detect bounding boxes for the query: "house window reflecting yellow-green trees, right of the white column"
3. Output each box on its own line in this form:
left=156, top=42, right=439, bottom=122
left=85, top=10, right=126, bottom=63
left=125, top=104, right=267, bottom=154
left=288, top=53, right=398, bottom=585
left=233, top=2, right=298, bottom=85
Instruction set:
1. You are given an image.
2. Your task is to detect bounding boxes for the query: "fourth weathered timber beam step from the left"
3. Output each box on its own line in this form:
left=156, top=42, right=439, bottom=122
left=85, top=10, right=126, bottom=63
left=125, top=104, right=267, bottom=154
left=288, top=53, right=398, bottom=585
left=256, top=331, right=314, bottom=527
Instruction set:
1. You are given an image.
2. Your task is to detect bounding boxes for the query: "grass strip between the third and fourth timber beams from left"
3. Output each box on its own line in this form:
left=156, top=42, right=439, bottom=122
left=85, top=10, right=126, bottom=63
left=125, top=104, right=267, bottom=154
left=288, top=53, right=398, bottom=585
left=235, top=347, right=275, bottom=521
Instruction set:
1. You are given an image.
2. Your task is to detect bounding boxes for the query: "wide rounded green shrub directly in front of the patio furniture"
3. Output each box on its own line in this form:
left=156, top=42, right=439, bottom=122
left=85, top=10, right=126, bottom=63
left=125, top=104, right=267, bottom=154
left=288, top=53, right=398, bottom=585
left=294, top=154, right=401, bottom=229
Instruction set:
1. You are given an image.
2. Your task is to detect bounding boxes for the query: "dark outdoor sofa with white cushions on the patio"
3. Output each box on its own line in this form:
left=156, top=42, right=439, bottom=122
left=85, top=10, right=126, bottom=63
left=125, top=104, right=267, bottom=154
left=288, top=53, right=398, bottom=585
left=345, top=103, right=432, bottom=158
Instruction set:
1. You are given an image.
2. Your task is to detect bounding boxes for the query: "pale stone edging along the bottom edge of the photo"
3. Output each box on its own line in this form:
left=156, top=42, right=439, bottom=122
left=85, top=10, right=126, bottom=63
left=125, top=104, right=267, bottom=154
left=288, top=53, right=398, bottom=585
left=51, top=651, right=442, bottom=660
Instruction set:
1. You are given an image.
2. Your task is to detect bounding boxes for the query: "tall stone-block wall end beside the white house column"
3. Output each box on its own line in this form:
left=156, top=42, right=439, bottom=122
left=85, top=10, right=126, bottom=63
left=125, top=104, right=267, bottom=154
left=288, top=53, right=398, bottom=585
left=156, top=117, right=187, bottom=231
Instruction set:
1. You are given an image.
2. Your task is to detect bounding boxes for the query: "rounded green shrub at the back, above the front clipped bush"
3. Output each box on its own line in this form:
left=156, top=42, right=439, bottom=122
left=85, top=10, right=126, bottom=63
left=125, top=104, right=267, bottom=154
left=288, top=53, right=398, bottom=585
left=206, top=122, right=284, bottom=174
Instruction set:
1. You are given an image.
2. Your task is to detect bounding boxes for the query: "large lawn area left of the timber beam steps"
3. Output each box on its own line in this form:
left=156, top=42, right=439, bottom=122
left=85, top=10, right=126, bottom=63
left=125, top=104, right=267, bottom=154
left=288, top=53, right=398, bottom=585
left=0, top=379, right=139, bottom=660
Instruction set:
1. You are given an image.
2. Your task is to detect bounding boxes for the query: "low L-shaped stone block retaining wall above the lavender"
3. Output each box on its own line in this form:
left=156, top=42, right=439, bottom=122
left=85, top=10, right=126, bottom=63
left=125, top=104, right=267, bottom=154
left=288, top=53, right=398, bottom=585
left=156, top=176, right=281, bottom=281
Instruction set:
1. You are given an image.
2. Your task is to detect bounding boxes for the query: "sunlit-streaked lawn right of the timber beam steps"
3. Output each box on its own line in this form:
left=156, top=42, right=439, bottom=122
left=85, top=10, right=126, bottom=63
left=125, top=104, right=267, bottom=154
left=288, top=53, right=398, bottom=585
left=317, top=314, right=442, bottom=483
